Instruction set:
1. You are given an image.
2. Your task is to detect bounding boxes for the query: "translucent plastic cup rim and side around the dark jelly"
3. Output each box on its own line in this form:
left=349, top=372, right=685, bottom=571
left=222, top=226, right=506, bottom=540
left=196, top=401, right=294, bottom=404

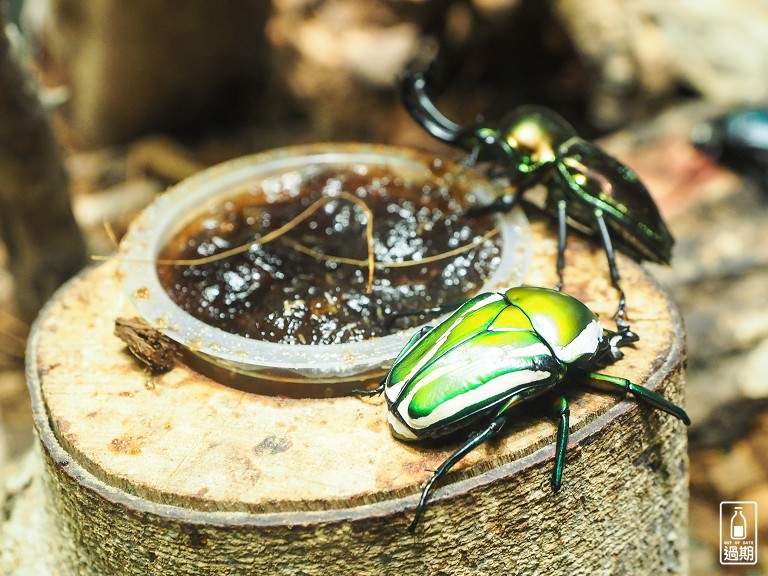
left=119, top=143, right=530, bottom=397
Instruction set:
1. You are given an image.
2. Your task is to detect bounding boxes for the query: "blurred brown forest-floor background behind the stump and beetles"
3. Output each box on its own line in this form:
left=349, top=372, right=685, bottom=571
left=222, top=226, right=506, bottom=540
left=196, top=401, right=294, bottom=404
left=0, top=0, right=768, bottom=575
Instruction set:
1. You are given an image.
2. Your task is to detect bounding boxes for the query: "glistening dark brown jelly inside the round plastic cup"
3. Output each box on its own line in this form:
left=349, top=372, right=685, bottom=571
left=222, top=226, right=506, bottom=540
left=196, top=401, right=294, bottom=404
left=158, top=168, right=501, bottom=344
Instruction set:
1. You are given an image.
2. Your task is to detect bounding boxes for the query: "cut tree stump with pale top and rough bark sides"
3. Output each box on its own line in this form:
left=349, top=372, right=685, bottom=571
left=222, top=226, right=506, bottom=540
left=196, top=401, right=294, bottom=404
left=28, top=221, right=688, bottom=575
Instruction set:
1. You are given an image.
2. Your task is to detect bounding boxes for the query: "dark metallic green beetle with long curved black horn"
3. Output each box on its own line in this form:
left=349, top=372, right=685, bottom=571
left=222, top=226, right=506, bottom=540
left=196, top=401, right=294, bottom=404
left=401, top=72, right=674, bottom=328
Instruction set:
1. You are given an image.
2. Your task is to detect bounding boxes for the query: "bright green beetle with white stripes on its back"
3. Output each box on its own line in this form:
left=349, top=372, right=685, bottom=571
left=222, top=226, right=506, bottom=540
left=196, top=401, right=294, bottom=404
left=357, top=286, right=690, bottom=530
